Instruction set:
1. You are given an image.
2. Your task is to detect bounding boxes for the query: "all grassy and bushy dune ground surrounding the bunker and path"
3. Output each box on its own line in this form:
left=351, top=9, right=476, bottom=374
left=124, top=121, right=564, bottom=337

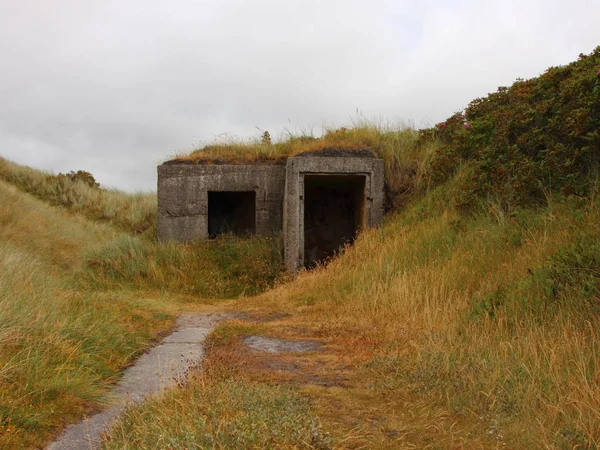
left=0, top=47, right=600, bottom=449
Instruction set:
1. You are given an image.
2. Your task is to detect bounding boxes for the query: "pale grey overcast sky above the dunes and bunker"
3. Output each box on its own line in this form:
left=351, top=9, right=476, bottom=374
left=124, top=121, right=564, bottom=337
left=0, top=0, right=600, bottom=191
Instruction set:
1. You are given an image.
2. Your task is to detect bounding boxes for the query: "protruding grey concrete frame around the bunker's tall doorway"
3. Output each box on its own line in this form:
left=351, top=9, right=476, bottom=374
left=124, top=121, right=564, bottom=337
left=283, top=156, right=385, bottom=272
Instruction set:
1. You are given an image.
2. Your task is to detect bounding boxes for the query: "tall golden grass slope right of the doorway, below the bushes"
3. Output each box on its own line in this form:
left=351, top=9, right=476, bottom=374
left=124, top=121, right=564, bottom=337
left=276, top=197, right=600, bottom=448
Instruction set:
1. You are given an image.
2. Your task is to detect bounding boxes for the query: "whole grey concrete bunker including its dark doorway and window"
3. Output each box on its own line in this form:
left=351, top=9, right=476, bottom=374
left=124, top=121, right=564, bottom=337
left=158, top=149, right=384, bottom=272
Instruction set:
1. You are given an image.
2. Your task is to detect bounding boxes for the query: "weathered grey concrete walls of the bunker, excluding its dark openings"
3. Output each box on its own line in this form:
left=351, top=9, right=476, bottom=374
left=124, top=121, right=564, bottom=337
left=158, top=149, right=385, bottom=273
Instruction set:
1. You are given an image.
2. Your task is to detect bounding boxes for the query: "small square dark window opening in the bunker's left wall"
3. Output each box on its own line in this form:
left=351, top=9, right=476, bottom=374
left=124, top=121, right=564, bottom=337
left=208, top=191, right=256, bottom=239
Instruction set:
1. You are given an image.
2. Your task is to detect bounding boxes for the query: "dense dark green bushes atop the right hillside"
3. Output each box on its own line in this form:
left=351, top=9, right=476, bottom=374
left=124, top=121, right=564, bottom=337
left=422, top=47, right=600, bottom=209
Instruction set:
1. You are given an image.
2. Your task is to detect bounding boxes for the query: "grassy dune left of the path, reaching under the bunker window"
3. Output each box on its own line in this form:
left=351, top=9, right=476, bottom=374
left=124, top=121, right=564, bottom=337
left=0, top=160, right=281, bottom=449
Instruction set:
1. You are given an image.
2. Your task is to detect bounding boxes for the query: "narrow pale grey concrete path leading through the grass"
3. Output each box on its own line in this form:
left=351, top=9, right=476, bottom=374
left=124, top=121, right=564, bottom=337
left=47, top=313, right=230, bottom=450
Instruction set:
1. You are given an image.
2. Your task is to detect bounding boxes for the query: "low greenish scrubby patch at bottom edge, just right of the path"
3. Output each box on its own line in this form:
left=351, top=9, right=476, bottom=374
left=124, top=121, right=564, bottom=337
left=104, top=375, right=331, bottom=450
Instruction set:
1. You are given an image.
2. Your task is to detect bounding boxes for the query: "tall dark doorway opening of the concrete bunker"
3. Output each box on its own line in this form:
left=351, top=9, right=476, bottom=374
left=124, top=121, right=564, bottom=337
left=303, top=174, right=366, bottom=267
